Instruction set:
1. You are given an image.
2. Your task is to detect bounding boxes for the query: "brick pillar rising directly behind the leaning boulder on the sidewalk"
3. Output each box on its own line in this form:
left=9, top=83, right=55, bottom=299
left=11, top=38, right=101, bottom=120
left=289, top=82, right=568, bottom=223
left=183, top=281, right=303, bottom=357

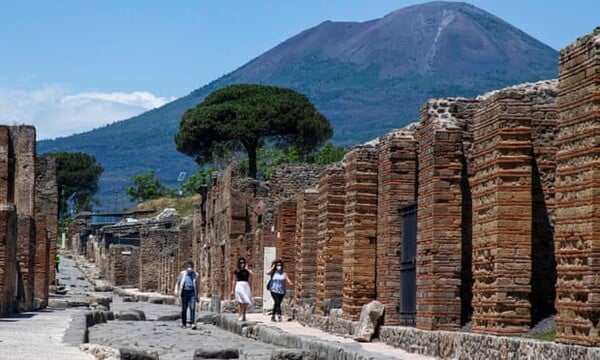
left=342, top=145, right=377, bottom=321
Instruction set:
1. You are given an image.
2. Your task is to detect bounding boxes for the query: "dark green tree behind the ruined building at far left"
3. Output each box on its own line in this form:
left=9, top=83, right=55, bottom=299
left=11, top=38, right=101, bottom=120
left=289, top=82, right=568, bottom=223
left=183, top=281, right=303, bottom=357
left=46, top=152, right=104, bottom=218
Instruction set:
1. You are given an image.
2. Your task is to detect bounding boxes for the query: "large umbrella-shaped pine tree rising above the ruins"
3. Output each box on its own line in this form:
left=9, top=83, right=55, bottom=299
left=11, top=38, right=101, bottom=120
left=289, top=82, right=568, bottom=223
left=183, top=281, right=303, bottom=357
left=175, top=84, right=333, bottom=178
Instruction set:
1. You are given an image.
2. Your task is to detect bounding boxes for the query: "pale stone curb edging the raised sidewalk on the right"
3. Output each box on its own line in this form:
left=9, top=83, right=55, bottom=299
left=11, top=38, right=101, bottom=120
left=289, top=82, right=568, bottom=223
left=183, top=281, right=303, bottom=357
left=214, top=314, right=396, bottom=360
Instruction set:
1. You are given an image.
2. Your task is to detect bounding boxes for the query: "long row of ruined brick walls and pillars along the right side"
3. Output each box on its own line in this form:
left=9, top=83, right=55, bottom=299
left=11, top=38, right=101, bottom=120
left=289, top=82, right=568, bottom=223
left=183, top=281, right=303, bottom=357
left=71, top=29, right=600, bottom=346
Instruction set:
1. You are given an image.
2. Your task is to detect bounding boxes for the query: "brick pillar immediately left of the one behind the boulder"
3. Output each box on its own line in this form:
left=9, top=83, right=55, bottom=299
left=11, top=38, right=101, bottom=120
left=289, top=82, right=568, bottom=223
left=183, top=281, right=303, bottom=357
left=315, top=165, right=346, bottom=315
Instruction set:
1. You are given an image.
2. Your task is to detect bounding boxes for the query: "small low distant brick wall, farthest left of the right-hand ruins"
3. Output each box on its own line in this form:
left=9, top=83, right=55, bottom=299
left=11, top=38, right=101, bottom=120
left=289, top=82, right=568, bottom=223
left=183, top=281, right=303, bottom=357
left=107, top=244, right=140, bottom=287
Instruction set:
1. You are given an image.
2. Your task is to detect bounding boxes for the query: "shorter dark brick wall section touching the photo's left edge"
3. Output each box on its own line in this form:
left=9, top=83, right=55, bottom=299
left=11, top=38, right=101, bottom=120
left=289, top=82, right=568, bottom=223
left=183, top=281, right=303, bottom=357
left=0, top=204, right=17, bottom=316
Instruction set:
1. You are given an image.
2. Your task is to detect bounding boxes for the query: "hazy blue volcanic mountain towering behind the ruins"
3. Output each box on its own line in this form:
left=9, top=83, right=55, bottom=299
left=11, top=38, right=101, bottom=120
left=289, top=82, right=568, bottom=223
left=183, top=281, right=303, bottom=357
left=38, top=2, right=558, bottom=208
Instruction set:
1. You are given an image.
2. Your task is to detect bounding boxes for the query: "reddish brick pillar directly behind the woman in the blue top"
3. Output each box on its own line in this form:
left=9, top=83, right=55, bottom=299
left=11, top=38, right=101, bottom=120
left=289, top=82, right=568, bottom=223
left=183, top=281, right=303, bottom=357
left=274, top=200, right=298, bottom=289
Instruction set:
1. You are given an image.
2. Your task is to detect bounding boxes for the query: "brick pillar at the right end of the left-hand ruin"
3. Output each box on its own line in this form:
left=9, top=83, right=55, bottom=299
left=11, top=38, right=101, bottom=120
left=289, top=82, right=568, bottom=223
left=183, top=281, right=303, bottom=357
left=34, top=157, right=58, bottom=303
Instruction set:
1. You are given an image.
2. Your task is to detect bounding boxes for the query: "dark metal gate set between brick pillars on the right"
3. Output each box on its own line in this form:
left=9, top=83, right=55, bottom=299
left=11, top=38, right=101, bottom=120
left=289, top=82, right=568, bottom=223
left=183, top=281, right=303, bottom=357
left=399, top=203, right=417, bottom=326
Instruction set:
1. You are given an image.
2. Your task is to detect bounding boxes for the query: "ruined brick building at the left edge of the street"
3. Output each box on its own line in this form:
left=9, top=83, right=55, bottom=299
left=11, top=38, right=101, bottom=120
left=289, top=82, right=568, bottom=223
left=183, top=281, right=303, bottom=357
left=0, top=126, right=58, bottom=316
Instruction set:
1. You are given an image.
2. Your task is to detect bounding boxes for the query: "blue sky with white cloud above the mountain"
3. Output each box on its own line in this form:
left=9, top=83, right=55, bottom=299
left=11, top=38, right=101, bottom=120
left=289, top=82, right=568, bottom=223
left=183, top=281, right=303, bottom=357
left=0, top=0, right=600, bottom=139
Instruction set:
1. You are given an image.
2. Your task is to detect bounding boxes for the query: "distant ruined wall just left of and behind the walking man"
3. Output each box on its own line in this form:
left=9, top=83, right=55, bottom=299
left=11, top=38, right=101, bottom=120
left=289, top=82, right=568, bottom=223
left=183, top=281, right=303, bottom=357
left=138, top=228, right=179, bottom=291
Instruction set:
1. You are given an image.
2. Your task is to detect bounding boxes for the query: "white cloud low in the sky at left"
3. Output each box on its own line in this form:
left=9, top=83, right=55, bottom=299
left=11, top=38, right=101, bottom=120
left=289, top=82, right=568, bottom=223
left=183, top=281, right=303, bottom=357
left=0, top=85, right=174, bottom=140
